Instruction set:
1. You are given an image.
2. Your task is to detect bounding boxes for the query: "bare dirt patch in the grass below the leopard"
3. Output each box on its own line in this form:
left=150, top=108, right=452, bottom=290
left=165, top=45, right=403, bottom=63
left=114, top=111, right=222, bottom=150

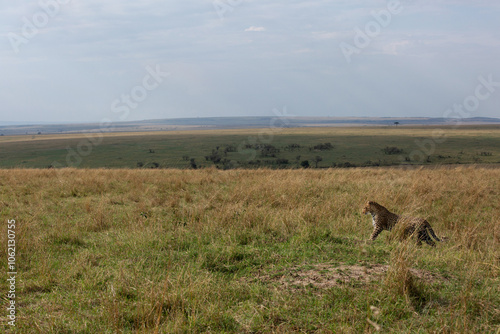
left=257, top=263, right=448, bottom=289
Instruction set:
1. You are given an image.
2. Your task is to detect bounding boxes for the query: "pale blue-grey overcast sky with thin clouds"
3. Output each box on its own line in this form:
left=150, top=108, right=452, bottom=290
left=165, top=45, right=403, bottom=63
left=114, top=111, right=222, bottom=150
left=0, top=0, right=500, bottom=123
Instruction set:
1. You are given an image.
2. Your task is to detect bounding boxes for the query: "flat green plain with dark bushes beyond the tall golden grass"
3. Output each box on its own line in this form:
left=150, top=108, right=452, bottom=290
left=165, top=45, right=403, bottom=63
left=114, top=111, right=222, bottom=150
left=0, top=126, right=500, bottom=168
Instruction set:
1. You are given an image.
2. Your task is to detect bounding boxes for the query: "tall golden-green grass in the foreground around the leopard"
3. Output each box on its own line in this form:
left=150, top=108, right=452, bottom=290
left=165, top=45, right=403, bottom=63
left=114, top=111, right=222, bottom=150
left=0, top=166, right=500, bottom=333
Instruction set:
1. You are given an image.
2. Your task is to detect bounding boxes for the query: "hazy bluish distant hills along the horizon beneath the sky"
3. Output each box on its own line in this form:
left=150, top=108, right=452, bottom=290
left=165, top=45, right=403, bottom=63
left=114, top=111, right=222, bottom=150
left=0, top=117, right=500, bottom=135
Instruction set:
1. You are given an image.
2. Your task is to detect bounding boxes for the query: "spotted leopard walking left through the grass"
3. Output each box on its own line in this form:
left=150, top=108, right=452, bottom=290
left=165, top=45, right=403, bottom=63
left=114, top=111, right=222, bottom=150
left=362, top=201, right=441, bottom=247
